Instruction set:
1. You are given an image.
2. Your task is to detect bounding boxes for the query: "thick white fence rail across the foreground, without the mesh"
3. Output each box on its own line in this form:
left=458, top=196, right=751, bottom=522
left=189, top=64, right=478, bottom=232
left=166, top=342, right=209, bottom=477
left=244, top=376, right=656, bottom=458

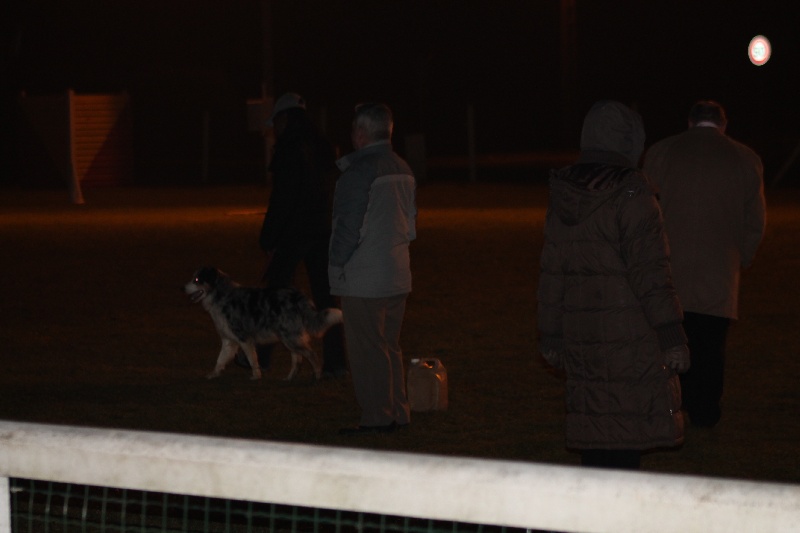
left=0, top=421, right=800, bottom=533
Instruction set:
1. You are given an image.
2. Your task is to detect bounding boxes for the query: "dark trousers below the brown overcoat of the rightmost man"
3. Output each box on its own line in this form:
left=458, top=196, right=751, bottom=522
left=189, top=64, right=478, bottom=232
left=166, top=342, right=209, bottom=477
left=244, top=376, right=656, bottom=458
left=680, top=313, right=730, bottom=427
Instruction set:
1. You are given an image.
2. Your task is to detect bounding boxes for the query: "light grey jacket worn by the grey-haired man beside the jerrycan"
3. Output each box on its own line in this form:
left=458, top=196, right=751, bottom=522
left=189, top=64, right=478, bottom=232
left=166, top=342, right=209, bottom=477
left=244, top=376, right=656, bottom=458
left=328, top=141, right=417, bottom=298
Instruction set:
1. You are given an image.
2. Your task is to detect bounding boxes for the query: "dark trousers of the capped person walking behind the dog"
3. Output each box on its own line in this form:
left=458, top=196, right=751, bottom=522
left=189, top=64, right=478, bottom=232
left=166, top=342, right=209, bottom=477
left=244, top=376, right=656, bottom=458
left=258, top=239, right=347, bottom=374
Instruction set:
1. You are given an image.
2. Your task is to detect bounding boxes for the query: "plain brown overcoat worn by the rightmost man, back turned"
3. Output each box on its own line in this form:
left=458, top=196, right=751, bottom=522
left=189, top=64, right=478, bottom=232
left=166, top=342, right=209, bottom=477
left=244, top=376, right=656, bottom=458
left=644, top=126, right=766, bottom=319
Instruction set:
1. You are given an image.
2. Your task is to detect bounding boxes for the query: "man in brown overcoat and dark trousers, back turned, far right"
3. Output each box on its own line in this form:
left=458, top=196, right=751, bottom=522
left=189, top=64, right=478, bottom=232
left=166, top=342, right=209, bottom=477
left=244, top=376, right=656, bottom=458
left=644, top=100, right=766, bottom=427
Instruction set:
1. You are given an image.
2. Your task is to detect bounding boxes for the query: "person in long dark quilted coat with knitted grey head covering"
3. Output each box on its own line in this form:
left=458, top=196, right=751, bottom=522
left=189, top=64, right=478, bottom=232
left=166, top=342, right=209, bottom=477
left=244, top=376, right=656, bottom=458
left=538, top=101, right=689, bottom=468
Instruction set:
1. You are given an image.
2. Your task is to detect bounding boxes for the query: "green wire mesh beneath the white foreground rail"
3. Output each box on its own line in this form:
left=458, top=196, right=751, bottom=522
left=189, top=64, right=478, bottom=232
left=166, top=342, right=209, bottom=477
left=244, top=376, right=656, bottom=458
left=9, top=478, right=530, bottom=533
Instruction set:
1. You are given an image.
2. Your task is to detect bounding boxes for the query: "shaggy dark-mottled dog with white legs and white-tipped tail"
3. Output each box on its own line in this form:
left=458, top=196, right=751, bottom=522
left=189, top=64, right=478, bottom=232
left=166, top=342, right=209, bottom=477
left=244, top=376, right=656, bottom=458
left=184, top=266, right=342, bottom=381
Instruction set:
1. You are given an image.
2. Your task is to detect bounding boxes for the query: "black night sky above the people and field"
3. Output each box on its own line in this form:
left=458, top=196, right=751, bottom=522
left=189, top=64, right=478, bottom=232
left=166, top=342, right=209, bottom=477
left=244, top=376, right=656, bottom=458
left=2, top=0, right=800, bottom=183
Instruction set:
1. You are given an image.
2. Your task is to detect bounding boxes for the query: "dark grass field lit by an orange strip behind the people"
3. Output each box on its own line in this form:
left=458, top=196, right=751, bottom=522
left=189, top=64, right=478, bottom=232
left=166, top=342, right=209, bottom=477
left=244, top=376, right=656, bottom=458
left=0, top=183, right=800, bottom=483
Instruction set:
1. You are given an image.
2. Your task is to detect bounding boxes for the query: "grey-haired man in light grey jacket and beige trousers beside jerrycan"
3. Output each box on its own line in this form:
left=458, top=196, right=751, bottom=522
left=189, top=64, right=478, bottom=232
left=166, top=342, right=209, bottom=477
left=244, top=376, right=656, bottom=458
left=328, top=103, right=417, bottom=434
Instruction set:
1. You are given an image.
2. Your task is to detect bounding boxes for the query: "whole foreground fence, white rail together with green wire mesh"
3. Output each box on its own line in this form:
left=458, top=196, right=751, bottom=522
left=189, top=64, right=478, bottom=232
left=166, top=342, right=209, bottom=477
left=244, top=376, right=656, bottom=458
left=0, top=421, right=800, bottom=533
